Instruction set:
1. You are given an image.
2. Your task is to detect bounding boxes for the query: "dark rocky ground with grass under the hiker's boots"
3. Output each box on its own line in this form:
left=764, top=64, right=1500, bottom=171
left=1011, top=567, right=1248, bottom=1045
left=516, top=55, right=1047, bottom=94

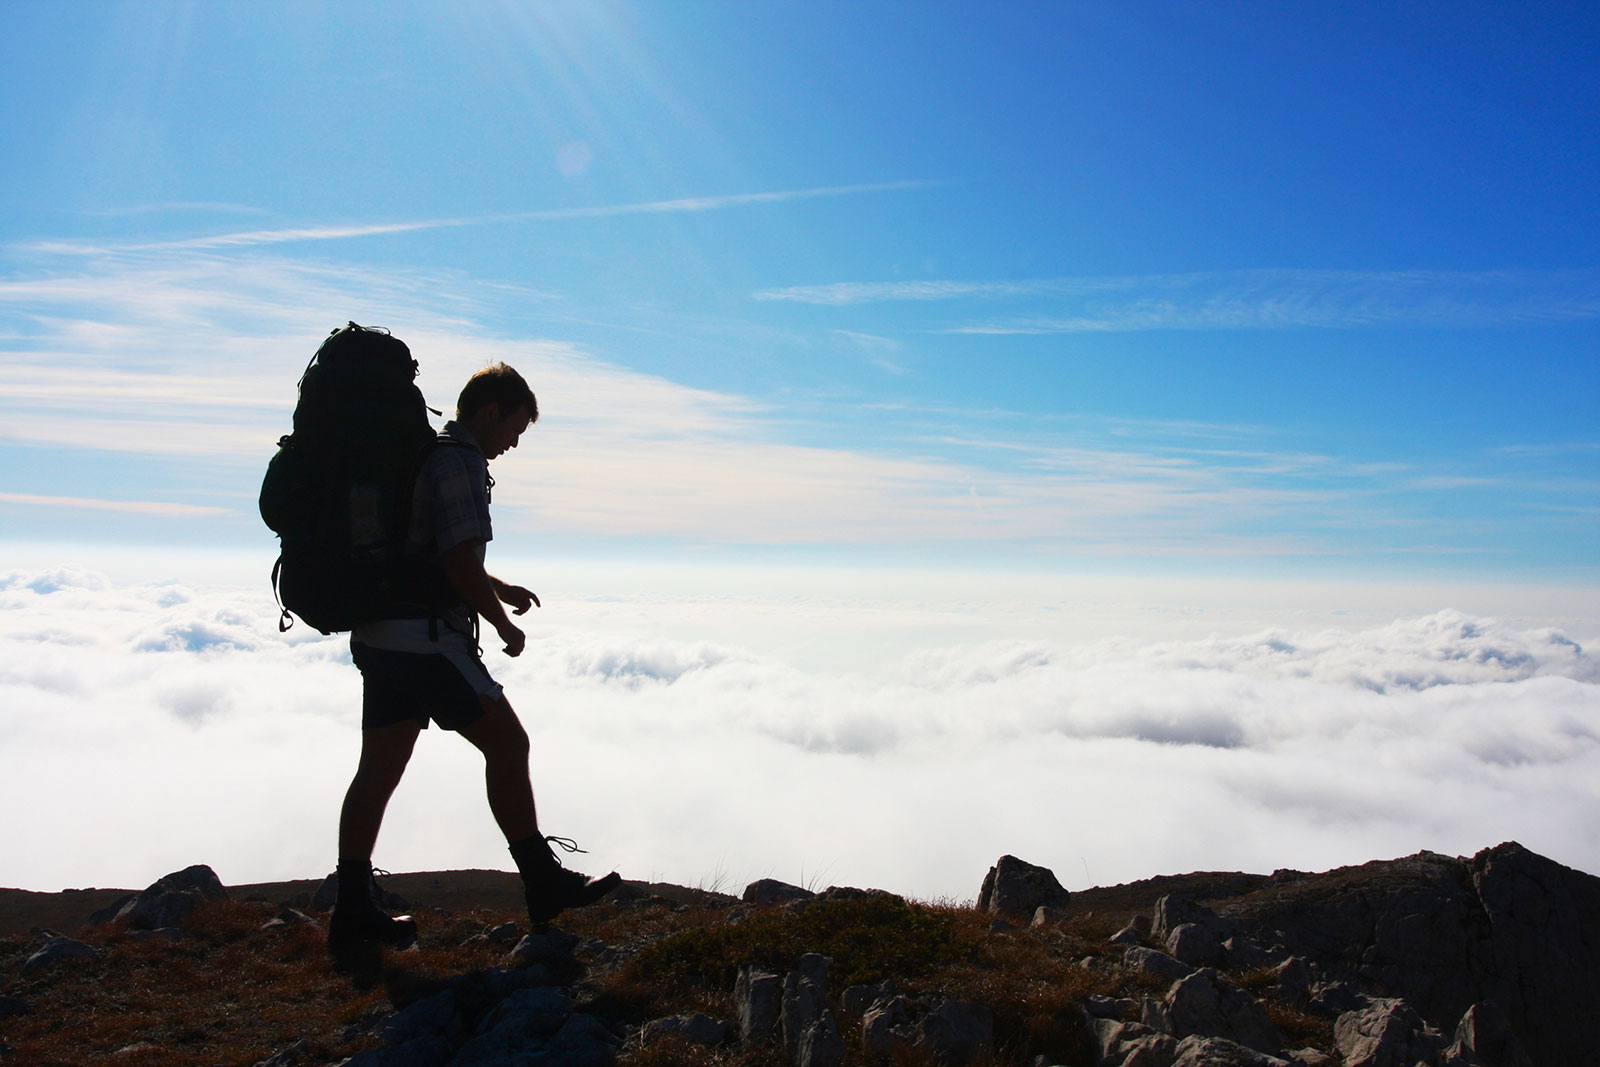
left=0, top=843, right=1600, bottom=1067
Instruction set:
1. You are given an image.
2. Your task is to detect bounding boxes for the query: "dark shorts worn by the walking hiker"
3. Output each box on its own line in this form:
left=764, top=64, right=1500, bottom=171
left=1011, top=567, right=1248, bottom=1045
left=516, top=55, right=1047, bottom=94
left=350, top=641, right=498, bottom=729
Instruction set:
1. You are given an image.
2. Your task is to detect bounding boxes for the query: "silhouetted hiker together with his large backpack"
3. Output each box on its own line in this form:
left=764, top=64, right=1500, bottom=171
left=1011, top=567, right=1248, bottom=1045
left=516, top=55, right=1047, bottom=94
left=261, top=323, right=621, bottom=963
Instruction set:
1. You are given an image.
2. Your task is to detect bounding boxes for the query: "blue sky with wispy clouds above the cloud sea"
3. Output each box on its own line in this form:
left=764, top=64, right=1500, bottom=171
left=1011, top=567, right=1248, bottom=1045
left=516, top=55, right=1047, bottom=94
left=0, top=2, right=1600, bottom=585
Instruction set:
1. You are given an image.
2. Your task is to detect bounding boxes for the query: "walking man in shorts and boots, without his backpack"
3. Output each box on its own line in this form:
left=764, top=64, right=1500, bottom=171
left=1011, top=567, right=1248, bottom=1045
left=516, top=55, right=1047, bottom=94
left=328, top=363, right=621, bottom=957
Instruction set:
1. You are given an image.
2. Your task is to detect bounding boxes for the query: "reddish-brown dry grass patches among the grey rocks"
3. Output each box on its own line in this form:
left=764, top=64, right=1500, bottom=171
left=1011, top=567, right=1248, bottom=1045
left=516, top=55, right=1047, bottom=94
left=0, top=876, right=1326, bottom=1067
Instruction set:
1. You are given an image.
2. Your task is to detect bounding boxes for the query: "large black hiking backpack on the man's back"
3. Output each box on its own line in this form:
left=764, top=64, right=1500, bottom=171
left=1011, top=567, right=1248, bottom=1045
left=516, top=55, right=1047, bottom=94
left=261, top=322, right=443, bottom=633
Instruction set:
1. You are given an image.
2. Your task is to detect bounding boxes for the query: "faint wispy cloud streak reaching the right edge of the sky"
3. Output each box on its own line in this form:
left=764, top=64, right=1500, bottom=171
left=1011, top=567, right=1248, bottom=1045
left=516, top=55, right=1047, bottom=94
left=752, top=269, right=1600, bottom=334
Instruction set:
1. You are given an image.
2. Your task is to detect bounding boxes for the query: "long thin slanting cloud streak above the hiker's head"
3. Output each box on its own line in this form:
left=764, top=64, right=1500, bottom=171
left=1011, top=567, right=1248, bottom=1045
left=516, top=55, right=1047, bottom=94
left=29, top=181, right=930, bottom=254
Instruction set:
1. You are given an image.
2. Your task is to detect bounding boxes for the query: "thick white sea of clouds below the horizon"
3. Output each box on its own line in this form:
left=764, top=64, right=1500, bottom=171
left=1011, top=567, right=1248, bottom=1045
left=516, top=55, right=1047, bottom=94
left=0, top=568, right=1600, bottom=899
